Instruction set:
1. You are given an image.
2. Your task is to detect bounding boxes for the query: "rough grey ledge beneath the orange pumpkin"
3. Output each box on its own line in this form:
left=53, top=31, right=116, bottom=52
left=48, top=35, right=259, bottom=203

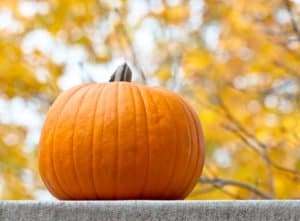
left=0, top=201, right=300, bottom=221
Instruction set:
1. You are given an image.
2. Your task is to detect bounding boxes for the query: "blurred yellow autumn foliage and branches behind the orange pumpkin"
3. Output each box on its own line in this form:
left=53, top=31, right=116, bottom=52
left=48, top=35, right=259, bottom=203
left=0, top=0, right=300, bottom=200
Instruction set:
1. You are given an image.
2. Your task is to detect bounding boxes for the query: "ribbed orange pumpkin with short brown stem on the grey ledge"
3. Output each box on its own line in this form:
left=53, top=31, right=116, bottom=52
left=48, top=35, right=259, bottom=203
left=39, top=64, right=204, bottom=200
